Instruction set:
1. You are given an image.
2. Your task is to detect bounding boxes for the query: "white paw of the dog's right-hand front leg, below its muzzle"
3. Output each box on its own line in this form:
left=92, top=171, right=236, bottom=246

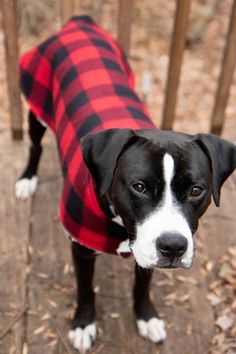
left=137, top=317, right=166, bottom=343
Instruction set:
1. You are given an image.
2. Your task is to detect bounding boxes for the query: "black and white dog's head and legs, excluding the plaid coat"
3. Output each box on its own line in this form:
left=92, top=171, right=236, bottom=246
left=15, top=112, right=236, bottom=352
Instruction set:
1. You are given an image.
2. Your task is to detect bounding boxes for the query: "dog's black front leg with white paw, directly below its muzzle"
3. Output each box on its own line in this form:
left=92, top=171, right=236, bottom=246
left=133, top=265, right=166, bottom=343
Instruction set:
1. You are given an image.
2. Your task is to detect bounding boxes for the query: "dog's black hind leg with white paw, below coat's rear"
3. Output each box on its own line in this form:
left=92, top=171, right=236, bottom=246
left=15, top=111, right=46, bottom=199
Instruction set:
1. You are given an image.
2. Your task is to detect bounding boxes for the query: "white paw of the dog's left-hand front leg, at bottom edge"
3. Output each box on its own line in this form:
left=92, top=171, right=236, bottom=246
left=68, top=323, right=96, bottom=354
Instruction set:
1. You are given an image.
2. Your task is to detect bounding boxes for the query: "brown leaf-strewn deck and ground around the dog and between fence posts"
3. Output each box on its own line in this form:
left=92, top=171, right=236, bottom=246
left=0, top=0, right=236, bottom=354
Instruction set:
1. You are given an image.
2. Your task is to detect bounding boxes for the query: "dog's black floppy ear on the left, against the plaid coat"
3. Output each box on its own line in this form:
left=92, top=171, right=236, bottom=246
left=81, top=129, right=135, bottom=196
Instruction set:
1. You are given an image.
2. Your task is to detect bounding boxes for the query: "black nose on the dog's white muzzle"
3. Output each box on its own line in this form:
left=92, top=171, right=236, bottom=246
left=156, top=233, right=188, bottom=259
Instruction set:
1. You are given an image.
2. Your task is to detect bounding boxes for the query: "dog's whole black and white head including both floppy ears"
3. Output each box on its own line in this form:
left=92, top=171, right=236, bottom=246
left=81, top=129, right=236, bottom=268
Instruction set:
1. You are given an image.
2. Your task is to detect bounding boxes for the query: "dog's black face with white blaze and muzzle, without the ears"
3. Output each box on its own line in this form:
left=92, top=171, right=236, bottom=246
left=110, top=132, right=212, bottom=268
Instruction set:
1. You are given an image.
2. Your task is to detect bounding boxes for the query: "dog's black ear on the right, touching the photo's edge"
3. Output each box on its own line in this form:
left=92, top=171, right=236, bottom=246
left=196, top=134, right=236, bottom=206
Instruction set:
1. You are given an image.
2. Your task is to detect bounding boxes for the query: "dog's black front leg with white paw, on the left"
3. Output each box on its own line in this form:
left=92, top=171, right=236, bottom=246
left=69, top=242, right=96, bottom=353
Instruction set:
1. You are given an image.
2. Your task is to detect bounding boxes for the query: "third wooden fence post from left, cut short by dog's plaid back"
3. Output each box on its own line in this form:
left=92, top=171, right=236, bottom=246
left=117, top=0, right=133, bottom=55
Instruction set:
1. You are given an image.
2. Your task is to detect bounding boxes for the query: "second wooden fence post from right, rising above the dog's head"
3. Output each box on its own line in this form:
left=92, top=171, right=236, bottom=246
left=161, top=0, right=190, bottom=130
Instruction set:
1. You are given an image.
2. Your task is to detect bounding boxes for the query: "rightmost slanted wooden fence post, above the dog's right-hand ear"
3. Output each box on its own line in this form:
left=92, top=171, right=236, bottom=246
left=210, top=0, right=236, bottom=135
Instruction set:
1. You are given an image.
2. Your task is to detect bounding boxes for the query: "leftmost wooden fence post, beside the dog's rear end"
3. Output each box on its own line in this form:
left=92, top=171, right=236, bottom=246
left=1, top=0, right=23, bottom=140
